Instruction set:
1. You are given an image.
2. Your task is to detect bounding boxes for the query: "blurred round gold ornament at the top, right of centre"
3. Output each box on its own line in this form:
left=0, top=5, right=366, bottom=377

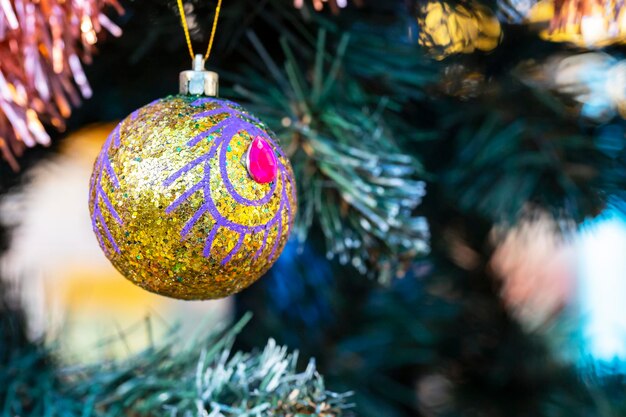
left=417, top=1, right=502, bottom=59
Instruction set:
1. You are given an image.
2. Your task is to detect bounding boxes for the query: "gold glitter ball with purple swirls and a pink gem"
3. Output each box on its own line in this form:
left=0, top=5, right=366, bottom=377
left=89, top=95, right=296, bottom=300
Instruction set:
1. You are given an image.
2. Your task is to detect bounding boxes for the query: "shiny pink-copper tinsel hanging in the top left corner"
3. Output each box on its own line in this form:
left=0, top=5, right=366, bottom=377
left=0, top=0, right=123, bottom=170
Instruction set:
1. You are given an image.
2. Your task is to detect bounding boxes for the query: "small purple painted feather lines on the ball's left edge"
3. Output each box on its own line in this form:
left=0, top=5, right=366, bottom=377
left=89, top=123, right=123, bottom=254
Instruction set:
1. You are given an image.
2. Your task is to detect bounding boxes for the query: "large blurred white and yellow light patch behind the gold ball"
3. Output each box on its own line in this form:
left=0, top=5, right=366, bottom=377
left=0, top=124, right=232, bottom=361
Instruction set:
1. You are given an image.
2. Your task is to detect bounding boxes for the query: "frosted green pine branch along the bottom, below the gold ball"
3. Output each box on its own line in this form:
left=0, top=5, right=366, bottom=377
left=0, top=288, right=351, bottom=417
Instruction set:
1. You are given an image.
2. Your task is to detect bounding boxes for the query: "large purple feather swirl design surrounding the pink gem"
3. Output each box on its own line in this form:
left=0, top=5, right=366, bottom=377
left=163, top=98, right=295, bottom=265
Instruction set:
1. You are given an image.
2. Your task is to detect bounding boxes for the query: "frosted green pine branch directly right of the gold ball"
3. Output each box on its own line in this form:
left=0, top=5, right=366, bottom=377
left=227, top=20, right=429, bottom=281
